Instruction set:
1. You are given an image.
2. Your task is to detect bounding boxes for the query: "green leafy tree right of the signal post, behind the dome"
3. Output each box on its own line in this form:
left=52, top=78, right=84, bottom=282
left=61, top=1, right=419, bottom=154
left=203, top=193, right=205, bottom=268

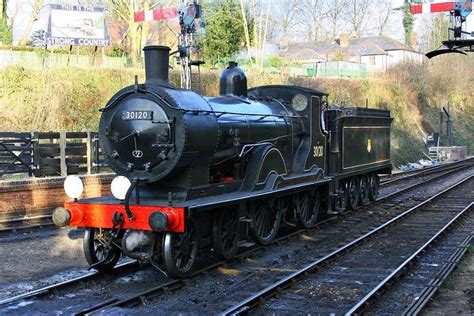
left=200, top=0, right=244, bottom=65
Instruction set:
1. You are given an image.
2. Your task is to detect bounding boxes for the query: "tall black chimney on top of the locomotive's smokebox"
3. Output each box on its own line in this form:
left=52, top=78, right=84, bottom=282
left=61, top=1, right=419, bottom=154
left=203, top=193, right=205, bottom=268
left=143, top=46, right=170, bottom=85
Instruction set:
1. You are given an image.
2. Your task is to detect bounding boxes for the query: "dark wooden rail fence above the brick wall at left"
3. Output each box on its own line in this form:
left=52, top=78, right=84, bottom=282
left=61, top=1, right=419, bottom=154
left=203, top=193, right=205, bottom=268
left=0, top=132, right=110, bottom=177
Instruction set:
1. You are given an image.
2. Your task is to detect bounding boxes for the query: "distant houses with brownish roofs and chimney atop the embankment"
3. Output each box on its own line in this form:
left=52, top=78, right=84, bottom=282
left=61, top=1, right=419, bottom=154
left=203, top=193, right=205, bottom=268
left=280, top=36, right=425, bottom=71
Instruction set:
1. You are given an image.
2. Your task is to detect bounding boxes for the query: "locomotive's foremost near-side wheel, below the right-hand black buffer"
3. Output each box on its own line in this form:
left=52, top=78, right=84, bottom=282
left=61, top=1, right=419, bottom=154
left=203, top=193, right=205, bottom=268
left=163, top=225, right=199, bottom=278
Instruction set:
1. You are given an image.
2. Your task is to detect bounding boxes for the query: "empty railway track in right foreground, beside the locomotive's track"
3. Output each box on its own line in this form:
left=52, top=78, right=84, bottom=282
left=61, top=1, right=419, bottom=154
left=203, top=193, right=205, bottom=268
left=223, top=175, right=474, bottom=315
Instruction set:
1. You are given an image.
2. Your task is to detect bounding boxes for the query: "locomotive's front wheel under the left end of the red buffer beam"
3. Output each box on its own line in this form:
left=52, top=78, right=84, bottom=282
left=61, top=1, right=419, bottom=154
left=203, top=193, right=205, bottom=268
left=83, top=228, right=122, bottom=272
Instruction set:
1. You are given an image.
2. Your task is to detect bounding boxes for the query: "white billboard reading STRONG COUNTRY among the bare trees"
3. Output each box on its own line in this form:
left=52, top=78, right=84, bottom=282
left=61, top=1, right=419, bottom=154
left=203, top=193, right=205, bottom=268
left=46, top=5, right=111, bottom=46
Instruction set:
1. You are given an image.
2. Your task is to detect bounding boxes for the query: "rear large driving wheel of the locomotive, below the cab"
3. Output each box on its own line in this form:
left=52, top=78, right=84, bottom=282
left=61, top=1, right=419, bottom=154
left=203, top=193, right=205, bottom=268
left=295, top=190, right=321, bottom=228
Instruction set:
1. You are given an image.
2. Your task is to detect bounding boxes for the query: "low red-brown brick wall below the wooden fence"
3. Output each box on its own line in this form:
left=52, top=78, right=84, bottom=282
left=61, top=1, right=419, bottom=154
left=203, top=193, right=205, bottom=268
left=0, top=174, right=114, bottom=219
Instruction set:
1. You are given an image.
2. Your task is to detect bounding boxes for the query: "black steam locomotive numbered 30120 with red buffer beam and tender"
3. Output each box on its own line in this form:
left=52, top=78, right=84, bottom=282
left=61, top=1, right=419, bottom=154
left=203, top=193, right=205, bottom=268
left=53, top=46, right=392, bottom=278
